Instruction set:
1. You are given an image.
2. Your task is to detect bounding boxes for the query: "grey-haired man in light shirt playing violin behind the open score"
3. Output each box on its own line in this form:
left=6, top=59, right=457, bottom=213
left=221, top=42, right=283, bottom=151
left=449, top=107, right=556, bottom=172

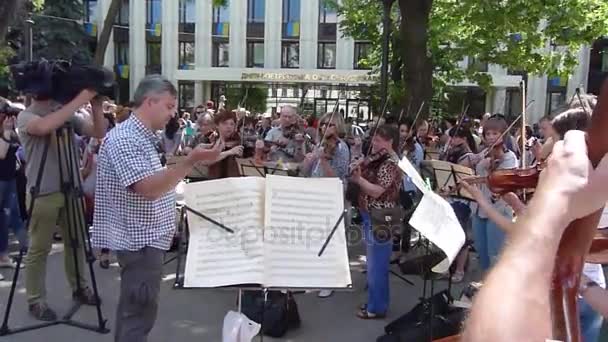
left=256, top=106, right=306, bottom=162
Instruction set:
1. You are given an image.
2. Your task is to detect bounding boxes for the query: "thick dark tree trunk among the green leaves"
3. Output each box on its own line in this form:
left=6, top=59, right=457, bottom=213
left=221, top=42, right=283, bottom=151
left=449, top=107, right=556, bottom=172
left=399, top=0, right=433, bottom=118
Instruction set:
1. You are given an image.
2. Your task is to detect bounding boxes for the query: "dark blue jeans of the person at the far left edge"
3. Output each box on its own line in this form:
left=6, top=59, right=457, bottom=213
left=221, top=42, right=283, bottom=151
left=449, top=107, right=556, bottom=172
left=0, top=179, right=27, bottom=256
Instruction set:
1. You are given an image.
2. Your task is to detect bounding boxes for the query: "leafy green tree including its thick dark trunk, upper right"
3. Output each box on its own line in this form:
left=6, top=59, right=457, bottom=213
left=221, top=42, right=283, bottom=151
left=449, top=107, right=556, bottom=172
left=334, top=0, right=608, bottom=119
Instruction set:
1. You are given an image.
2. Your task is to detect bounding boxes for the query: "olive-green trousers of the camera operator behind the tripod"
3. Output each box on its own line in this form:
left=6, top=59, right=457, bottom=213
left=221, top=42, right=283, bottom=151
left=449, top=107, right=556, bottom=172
left=25, top=192, right=86, bottom=304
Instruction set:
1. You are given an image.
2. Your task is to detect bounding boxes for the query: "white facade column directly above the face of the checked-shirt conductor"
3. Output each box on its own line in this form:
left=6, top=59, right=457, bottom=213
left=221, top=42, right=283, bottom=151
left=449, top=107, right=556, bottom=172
left=160, top=0, right=179, bottom=86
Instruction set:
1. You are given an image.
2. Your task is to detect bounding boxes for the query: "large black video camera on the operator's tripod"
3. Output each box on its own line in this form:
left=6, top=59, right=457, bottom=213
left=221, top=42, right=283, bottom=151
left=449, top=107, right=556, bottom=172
left=11, top=59, right=114, bottom=104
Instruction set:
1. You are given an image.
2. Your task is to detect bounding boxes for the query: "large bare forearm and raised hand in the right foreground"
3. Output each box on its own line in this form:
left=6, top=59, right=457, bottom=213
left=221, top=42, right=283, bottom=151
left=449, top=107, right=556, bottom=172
left=463, top=131, right=608, bottom=342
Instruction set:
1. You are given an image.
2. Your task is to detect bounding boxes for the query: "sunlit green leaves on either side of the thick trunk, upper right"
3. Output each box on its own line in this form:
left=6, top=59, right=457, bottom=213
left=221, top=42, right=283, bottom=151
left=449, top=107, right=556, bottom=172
left=332, top=0, right=608, bottom=106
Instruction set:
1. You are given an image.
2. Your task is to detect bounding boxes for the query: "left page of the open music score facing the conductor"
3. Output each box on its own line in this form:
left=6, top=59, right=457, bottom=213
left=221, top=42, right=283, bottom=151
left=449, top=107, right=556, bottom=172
left=184, top=177, right=265, bottom=287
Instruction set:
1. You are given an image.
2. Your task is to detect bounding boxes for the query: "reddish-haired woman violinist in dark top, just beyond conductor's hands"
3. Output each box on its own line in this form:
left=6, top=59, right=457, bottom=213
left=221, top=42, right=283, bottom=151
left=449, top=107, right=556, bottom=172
left=207, top=109, right=243, bottom=179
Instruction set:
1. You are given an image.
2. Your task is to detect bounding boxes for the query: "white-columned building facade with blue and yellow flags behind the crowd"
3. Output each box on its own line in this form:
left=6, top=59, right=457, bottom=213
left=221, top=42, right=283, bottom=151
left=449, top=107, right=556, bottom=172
left=85, top=0, right=589, bottom=122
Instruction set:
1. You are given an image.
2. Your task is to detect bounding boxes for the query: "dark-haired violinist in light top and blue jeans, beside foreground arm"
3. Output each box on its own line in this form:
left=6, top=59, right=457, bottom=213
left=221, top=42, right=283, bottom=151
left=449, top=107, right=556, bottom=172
left=473, top=116, right=518, bottom=271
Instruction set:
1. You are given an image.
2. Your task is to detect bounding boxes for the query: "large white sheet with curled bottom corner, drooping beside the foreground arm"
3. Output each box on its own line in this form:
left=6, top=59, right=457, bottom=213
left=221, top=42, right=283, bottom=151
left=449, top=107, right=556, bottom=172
left=409, top=191, right=465, bottom=273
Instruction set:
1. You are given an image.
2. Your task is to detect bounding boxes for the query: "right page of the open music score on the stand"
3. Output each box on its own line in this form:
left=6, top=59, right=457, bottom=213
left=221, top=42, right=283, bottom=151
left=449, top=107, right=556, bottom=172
left=264, top=175, right=352, bottom=288
